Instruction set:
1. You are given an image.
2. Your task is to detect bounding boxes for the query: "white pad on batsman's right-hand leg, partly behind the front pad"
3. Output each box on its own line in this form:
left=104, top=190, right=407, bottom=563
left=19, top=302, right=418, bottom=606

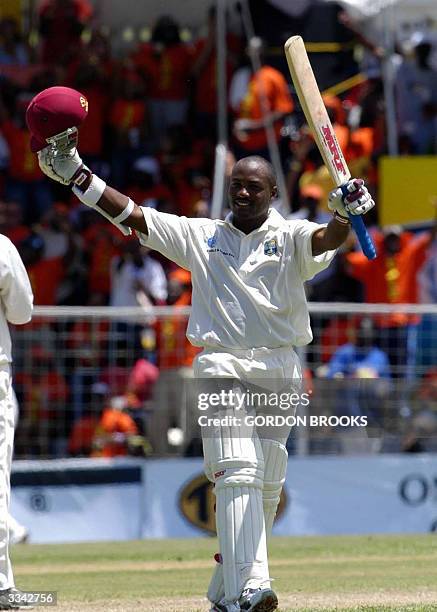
left=260, top=439, right=288, bottom=539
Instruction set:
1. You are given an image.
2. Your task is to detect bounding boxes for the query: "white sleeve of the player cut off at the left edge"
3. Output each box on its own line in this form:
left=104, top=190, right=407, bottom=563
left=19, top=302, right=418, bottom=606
left=0, top=238, right=33, bottom=325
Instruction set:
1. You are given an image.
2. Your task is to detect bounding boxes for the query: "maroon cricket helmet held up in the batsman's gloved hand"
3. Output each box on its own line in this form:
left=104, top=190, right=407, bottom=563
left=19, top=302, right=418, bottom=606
left=26, top=87, right=88, bottom=153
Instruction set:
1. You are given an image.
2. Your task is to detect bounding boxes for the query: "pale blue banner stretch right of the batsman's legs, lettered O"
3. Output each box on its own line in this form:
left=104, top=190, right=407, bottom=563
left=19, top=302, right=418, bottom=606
left=274, top=454, right=437, bottom=535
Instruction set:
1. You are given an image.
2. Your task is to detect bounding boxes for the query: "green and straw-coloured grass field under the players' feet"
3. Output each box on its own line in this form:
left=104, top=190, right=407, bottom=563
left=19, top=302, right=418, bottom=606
left=9, top=535, right=437, bottom=612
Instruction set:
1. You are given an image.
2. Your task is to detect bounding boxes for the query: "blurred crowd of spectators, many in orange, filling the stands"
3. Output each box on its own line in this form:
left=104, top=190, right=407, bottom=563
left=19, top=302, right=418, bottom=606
left=0, top=0, right=437, bottom=454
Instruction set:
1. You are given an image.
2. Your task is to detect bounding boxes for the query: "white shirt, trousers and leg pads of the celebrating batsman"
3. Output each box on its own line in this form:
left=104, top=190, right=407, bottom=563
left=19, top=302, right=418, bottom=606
left=138, top=208, right=335, bottom=603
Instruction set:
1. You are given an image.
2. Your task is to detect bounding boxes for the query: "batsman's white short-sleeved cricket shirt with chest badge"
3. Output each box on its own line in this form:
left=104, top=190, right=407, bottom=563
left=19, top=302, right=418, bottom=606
left=137, top=207, right=335, bottom=349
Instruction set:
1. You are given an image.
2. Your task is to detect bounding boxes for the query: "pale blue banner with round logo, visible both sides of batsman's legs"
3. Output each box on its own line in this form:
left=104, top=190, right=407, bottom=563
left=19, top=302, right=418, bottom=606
left=143, top=454, right=437, bottom=538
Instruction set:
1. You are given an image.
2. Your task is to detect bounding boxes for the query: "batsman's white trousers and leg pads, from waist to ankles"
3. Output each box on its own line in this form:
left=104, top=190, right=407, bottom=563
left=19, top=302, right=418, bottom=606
left=194, top=347, right=302, bottom=603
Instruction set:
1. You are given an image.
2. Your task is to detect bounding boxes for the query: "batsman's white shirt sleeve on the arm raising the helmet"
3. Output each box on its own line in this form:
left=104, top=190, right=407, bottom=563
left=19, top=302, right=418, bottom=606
left=137, top=206, right=191, bottom=270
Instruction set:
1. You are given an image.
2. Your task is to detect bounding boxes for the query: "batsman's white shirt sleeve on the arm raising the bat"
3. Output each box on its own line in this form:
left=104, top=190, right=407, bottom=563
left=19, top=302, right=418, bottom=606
left=290, top=220, right=336, bottom=281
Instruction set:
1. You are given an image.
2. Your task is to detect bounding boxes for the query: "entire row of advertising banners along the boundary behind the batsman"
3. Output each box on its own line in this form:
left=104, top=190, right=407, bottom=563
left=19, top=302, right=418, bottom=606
left=11, top=454, right=437, bottom=543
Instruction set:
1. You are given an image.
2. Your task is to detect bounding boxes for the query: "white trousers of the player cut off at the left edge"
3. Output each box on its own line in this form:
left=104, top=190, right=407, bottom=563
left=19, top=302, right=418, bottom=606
left=0, top=365, right=15, bottom=590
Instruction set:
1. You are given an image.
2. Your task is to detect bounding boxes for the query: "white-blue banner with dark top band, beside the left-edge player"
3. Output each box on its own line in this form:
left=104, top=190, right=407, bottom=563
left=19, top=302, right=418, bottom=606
left=11, top=459, right=144, bottom=543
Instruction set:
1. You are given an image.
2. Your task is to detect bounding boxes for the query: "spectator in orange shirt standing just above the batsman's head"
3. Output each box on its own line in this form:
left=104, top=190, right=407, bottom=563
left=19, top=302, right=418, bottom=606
left=233, top=39, right=294, bottom=158
